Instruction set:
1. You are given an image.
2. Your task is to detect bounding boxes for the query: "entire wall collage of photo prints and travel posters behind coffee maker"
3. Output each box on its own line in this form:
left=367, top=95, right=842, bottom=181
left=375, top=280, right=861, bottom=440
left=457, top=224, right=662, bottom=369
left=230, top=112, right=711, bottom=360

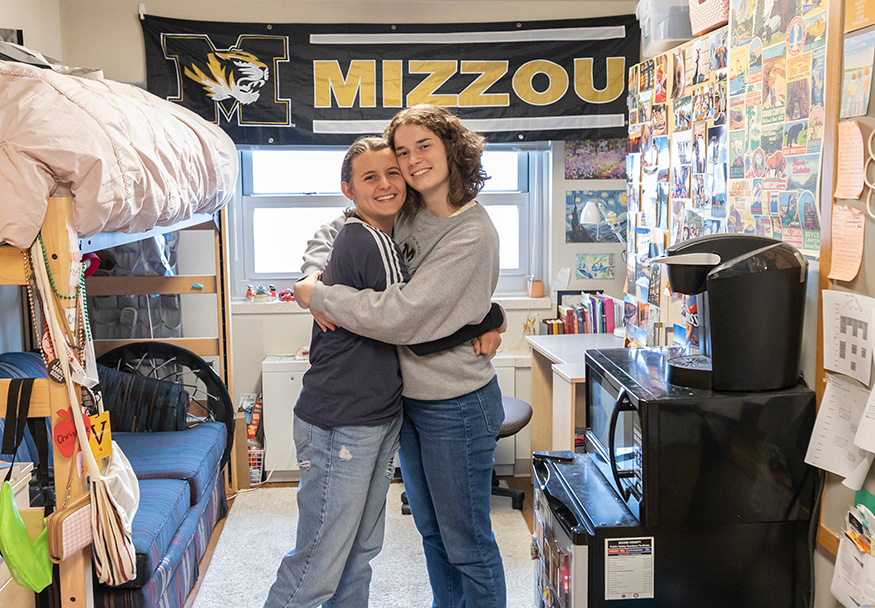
left=625, top=0, right=827, bottom=352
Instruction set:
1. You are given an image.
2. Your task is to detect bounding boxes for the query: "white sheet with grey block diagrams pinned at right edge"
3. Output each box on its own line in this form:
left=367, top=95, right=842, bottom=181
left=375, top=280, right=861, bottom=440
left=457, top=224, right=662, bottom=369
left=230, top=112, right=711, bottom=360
left=823, top=290, right=875, bottom=386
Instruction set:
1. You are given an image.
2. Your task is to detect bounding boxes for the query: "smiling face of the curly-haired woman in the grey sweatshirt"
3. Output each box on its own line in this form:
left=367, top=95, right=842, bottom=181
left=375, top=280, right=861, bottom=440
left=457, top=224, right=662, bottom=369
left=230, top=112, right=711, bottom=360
left=394, top=124, right=450, bottom=207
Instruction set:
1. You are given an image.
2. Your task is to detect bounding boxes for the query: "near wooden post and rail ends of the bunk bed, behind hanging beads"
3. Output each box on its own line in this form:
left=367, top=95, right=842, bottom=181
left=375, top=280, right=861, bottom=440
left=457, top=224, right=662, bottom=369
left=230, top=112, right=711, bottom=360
left=0, top=196, right=94, bottom=608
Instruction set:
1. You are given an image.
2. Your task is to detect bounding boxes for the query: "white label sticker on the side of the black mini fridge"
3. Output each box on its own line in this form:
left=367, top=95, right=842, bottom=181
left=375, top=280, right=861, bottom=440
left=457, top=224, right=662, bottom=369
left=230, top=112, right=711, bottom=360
left=605, top=536, right=653, bottom=600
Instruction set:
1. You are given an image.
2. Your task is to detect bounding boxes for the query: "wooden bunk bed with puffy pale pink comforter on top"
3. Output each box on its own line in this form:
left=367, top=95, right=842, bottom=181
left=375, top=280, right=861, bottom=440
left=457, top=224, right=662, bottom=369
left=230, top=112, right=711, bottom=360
left=0, top=61, right=240, bottom=608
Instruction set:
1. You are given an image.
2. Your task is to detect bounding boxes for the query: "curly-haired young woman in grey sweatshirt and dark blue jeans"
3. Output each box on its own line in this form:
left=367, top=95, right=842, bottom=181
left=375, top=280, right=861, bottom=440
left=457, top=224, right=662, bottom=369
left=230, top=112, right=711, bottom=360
left=295, top=105, right=506, bottom=608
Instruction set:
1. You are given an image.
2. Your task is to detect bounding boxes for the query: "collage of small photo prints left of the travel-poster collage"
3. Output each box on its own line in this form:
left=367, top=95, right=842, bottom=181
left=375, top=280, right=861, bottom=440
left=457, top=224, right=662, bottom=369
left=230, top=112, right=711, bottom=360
left=625, top=28, right=732, bottom=352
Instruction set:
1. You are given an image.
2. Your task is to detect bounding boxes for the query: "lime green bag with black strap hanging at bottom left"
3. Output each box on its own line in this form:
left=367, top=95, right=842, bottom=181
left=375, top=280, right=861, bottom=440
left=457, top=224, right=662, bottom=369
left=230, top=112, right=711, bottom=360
left=0, top=378, right=52, bottom=592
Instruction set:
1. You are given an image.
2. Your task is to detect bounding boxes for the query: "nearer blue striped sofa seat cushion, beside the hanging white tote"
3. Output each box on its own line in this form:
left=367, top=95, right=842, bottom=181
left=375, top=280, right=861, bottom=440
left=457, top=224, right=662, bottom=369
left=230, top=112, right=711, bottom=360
left=127, top=479, right=190, bottom=587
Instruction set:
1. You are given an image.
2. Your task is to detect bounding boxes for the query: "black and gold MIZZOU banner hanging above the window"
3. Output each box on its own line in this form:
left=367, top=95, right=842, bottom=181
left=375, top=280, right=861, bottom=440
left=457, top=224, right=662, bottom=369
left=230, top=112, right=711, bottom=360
left=141, top=16, right=640, bottom=145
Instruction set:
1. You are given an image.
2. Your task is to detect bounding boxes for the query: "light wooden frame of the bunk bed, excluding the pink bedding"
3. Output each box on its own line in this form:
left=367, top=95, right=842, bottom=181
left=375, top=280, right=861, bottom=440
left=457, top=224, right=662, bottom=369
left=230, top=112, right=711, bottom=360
left=0, top=196, right=249, bottom=608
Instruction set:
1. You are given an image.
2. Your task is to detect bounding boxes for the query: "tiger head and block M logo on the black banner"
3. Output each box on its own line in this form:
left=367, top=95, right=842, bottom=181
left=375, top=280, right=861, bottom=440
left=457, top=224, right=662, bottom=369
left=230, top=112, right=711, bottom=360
left=162, top=34, right=294, bottom=126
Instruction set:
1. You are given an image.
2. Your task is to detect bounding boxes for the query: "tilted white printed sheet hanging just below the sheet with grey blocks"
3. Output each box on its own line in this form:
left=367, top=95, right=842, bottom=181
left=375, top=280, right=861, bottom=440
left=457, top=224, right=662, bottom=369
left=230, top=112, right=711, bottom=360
left=805, top=375, right=871, bottom=482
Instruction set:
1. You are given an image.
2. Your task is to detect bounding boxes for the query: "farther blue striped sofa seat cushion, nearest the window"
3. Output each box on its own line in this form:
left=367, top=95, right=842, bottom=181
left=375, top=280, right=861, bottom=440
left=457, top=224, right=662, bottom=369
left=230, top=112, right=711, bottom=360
left=112, top=422, right=227, bottom=504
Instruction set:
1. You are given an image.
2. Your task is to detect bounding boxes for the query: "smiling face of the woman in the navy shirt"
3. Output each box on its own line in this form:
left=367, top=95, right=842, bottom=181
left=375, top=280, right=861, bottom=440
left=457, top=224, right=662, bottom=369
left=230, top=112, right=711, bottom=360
left=340, top=148, right=407, bottom=233
